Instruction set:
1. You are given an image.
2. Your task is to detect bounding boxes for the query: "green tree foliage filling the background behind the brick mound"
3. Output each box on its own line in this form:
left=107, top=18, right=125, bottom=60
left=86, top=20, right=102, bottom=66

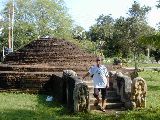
left=0, top=0, right=160, bottom=61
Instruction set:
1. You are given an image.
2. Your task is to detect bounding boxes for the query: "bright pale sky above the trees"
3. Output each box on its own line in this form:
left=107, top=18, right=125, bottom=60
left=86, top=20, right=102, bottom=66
left=64, top=0, right=160, bottom=30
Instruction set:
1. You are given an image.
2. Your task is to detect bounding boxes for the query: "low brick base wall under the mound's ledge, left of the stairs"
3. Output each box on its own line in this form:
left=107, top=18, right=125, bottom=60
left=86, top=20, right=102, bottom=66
left=0, top=71, right=62, bottom=89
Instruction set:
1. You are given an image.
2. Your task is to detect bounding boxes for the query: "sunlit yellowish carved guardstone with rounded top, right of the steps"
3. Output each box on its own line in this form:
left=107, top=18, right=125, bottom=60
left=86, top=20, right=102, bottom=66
left=131, top=77, right=147, bottom=108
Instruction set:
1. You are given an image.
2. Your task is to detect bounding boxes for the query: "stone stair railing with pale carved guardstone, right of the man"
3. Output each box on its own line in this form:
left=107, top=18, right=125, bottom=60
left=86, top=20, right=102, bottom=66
left=110, top=72, right=147, bottom=109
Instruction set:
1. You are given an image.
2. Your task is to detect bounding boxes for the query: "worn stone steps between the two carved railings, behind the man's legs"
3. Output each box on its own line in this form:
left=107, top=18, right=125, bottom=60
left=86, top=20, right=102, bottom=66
left=84, top=78, right=124, bottom=110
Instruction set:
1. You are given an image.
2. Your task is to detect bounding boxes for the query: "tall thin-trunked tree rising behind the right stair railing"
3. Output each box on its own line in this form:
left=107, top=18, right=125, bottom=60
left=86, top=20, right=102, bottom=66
left=127, top=1, right=151, bottom=69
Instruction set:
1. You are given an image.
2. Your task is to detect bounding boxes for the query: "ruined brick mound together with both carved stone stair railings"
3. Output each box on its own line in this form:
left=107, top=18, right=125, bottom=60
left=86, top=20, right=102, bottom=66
left=0, top=38, right=146, bottom=112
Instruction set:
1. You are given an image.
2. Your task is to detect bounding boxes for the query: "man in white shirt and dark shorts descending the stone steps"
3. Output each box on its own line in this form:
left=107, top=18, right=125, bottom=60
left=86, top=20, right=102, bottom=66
left=82, top=57, right=109, bottom=112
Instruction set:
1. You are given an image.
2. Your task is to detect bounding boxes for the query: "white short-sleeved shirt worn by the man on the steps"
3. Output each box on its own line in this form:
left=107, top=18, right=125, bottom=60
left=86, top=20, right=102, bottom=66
left=88, top=65, right=108, bottom=88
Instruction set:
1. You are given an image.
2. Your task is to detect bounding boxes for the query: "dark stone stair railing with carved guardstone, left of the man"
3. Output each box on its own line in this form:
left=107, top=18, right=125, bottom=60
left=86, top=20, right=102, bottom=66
left=63, top=70, right=89, bottom=112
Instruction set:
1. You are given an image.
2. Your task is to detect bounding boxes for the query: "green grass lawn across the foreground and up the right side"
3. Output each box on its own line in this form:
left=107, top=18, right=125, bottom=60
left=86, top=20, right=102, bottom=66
left=0, top=71, right=160, bottom=120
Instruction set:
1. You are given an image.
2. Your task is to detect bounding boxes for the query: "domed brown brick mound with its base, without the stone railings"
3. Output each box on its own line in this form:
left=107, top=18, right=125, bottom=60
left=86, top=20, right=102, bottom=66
left=0, top=38, right=96, bottom=93
